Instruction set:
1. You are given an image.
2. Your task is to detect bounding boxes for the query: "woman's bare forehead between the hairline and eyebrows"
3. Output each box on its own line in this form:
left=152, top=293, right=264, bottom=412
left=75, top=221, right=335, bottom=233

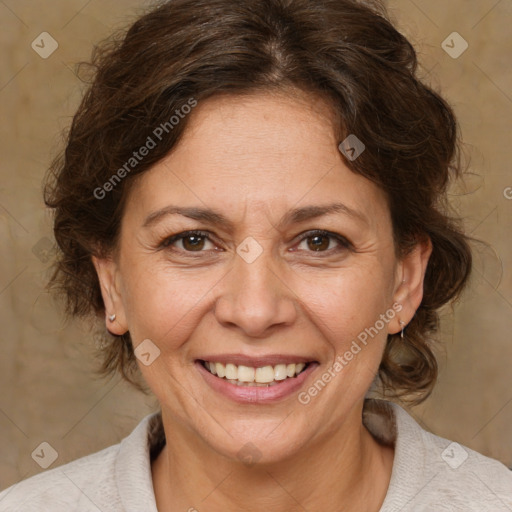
left=123, top=93, right=387, bottom=230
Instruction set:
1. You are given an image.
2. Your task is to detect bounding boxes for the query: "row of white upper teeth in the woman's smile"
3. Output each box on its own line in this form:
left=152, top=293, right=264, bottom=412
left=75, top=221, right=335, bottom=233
left=205, top=361, right=306, bottom=384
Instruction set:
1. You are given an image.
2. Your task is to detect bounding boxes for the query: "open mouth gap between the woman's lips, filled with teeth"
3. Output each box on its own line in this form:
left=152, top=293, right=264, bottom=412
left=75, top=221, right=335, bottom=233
left=199, top=360, right=314, bottom=387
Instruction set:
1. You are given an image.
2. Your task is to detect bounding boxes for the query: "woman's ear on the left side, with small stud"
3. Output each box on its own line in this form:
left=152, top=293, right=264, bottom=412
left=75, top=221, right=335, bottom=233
left=92, top=256, right=128, bottom=336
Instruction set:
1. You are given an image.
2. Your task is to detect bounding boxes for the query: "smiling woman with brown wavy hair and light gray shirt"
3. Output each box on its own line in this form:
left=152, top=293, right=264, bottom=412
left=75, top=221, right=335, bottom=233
left=0, top=0, right=512, bottom=512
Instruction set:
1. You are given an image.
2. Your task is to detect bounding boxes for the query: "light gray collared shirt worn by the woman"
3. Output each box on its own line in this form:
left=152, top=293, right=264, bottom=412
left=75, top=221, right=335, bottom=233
left=0, top=400, right=512, bottom=512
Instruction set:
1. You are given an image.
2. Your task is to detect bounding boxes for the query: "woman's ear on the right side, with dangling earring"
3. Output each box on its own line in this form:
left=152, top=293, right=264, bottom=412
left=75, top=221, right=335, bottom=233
left=388, top=237, right=432, bottom=334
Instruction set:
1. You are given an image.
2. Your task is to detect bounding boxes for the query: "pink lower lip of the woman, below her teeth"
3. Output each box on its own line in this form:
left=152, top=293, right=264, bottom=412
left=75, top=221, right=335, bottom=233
left=195, top=361, right=318, bottom=404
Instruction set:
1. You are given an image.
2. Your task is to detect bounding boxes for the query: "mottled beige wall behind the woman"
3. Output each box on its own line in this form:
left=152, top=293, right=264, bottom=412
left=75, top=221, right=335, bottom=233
left=0, top=0, right=512, bottom=489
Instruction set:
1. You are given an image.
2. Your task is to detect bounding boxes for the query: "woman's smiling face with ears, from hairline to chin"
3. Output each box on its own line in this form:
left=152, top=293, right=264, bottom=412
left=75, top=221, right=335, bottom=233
left=94, top=93, right=428, bottom=461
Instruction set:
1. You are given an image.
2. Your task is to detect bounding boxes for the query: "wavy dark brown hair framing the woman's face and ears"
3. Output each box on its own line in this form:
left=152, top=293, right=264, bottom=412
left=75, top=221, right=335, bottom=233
left=45, top=0, right=471, bottom=403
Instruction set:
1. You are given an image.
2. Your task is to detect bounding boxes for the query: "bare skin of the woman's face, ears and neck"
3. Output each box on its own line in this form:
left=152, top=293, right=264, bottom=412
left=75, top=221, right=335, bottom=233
left=93, top=93, right=431, bottom=512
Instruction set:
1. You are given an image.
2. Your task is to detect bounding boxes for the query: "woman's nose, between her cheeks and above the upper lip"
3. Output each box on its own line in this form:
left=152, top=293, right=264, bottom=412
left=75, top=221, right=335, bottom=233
left=215, top=249, right=297, bottom=338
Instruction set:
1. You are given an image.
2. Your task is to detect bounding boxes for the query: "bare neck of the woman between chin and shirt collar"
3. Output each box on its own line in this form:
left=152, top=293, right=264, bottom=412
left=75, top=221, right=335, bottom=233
left=152, top=404, right=393, bottom=512
